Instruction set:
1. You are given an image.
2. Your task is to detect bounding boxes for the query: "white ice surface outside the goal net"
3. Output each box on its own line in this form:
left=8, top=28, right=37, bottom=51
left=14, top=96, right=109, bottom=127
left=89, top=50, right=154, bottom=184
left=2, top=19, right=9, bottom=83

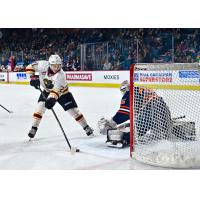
left=0, top=84, right=164, bottom=170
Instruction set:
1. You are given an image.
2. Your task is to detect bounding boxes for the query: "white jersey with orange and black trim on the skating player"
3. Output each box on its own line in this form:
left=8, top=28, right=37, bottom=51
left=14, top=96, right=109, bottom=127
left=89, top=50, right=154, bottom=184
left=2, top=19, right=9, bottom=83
left=26, top=60, right=68, bottom=99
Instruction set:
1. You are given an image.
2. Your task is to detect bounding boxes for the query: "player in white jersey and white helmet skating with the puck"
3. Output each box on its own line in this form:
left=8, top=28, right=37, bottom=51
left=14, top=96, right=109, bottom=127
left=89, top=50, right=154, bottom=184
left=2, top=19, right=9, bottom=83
left=26, top=55, right=93, bottom=138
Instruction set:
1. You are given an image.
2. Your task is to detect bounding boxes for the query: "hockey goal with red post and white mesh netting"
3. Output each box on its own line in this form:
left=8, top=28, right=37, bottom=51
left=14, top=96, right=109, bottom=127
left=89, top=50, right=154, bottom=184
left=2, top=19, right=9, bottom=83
left=130, top=63, right=200, bottom=169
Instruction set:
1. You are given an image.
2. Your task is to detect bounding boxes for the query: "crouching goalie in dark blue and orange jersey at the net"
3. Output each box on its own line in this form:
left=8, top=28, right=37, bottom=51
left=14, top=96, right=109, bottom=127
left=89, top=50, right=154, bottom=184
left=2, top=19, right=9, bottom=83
left=98, top=81, right=195, bottom=147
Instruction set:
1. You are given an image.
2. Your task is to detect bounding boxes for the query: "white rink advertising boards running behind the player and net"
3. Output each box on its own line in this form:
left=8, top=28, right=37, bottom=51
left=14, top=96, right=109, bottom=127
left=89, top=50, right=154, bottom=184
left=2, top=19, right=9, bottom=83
left=0, top=70, right=200, bottom=87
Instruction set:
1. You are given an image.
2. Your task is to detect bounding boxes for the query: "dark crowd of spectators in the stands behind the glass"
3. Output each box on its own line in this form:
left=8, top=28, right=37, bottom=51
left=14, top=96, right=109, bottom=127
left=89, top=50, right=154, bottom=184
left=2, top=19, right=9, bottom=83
left=0, top=28, right=200, bottom=71
